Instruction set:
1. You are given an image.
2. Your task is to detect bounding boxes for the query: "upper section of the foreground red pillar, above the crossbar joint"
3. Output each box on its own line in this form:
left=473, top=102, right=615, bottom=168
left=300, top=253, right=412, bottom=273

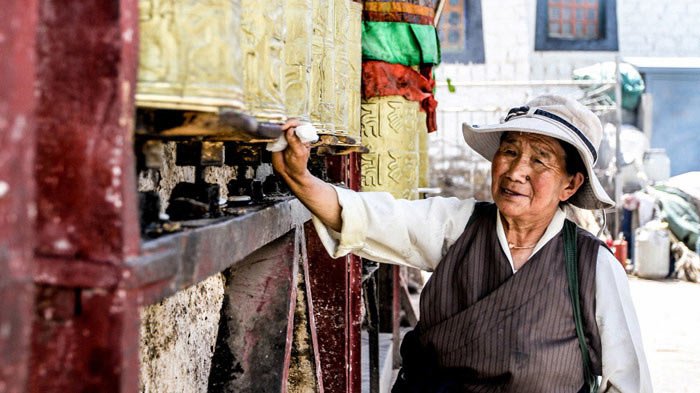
left=36, top=0, right=139, bottom=264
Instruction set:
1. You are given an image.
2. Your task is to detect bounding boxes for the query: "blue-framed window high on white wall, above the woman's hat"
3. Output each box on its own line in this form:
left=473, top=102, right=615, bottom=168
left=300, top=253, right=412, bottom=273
left=535, top=0, right=618, bottom=51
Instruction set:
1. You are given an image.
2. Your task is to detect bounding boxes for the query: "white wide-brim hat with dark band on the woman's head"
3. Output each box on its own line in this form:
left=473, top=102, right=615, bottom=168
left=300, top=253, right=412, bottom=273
left=462, top=95, right=615, bottom=210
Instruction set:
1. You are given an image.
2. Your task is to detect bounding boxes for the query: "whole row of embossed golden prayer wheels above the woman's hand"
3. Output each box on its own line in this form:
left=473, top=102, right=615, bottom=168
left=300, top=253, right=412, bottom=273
left=136, top=0, right=362, bottom=146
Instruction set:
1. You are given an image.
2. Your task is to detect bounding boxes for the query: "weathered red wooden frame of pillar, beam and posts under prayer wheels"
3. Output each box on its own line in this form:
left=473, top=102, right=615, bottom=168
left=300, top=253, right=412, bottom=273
left=0, top=0, right=361, bottom=392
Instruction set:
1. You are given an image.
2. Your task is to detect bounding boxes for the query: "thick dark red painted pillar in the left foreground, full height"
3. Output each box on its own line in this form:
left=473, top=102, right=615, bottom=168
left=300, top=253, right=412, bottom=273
left=28, top=0, right=140, bottom=392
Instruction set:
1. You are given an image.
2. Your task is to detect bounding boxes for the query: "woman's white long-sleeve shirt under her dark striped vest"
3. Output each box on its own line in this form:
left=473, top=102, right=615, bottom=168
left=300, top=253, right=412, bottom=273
left=313, top=187, right=652, bottom=393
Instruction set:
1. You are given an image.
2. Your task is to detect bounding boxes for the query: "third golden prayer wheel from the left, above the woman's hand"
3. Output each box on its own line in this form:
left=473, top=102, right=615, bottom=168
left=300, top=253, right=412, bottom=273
left=284, top=0, right=313, bottom=121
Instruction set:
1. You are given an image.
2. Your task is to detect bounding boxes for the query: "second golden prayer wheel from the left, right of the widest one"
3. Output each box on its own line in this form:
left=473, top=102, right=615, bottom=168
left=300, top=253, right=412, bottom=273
left=241, top=0, right=286, bottom=122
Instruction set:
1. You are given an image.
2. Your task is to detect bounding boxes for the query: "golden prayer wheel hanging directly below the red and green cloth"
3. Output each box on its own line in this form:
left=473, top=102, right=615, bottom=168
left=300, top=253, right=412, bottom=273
left=361, top=96, right=418, bottom=199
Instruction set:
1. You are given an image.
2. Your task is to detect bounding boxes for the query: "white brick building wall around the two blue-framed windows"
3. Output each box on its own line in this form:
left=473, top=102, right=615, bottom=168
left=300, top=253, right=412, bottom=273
left=430, top=0, right=700, bottom=197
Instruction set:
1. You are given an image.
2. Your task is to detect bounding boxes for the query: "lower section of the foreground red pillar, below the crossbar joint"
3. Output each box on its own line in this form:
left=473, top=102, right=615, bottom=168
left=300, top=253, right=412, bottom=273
left=29, top=286, right=139, bottom=392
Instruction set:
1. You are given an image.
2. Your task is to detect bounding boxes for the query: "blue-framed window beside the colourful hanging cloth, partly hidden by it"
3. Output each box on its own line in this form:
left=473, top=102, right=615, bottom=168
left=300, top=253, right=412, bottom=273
left=438, top=0, right=484, bottom=63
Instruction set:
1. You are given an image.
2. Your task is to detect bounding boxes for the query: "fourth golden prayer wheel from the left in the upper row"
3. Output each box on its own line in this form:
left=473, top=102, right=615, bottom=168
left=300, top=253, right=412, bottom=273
left=311, top=0, right=336, bottom=134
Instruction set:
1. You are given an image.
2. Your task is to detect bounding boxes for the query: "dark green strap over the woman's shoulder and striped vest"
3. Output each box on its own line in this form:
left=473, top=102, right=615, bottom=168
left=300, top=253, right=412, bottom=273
left=564, top=220, right=599, bottom=393
